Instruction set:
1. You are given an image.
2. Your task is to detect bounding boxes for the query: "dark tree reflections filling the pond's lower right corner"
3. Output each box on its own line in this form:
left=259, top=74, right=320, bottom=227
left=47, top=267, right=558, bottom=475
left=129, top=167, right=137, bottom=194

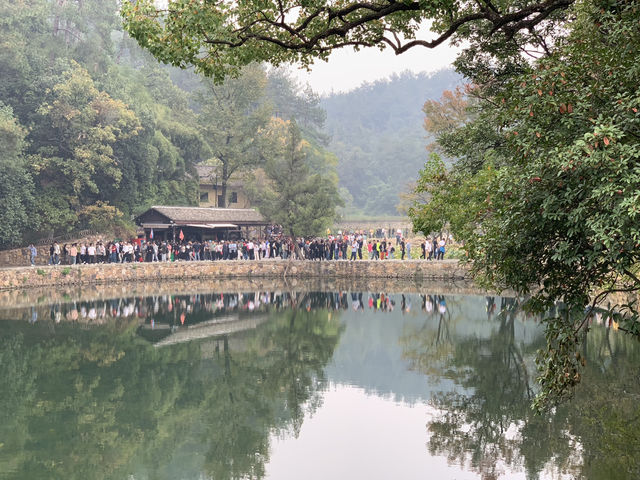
left=402, top=304, right=640, bottom=480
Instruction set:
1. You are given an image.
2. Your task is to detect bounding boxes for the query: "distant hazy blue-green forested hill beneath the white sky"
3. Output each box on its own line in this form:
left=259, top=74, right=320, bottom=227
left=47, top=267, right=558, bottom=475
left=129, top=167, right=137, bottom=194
left=322, top=70, right=462, bottom=215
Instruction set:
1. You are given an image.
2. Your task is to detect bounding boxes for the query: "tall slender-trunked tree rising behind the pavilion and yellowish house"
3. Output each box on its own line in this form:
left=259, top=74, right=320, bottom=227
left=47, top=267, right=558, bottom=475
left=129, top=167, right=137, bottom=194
left=196, top=64, right=271, bottom=207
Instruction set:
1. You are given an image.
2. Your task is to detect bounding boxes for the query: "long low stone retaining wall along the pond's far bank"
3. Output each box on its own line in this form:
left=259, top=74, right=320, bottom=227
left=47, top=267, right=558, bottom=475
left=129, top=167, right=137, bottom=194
left=0, top=260, right=468, bottom=290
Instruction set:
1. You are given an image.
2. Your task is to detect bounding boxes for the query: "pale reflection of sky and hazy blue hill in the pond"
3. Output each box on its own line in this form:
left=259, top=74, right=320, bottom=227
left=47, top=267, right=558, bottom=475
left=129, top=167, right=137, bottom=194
left=267, top=294, right=559, bottom=480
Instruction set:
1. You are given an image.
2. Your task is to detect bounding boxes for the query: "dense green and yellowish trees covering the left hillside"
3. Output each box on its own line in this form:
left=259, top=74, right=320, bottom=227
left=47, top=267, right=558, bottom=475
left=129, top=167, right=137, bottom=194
left=0, top=0, right=197, bottom=240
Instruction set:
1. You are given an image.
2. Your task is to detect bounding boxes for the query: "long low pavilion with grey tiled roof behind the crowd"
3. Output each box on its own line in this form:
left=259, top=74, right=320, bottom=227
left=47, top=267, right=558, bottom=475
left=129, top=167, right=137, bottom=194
left=136, top=206, right=267, bottom=240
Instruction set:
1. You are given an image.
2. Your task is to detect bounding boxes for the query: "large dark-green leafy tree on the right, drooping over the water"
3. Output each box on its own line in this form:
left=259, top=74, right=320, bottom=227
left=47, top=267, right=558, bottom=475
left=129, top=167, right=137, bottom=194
left=412, top=1, right=640, bottom=408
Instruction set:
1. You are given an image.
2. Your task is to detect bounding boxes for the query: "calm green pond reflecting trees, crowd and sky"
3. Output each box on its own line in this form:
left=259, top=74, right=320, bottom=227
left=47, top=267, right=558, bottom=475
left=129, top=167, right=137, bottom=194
left=0, top=282, right=640, bottom=480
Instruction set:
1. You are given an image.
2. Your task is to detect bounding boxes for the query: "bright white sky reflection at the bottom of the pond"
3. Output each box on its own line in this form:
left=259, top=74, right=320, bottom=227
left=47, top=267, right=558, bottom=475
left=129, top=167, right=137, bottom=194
left=266, top=385, right=540, bottom=480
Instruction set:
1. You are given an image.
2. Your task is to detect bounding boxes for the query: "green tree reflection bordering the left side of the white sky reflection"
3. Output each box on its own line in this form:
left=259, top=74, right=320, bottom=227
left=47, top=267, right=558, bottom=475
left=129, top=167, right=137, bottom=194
left=203, top=302, right=340, bottom=479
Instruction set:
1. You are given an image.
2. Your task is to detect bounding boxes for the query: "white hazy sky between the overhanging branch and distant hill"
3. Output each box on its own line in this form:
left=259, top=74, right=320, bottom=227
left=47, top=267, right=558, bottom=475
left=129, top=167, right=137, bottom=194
left=291, top=28, right=459, bottom=94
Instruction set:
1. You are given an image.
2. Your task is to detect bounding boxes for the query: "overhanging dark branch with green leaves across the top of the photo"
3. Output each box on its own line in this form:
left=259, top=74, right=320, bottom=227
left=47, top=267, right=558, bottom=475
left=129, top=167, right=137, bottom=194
left=122, top=0, right=574, bottom=79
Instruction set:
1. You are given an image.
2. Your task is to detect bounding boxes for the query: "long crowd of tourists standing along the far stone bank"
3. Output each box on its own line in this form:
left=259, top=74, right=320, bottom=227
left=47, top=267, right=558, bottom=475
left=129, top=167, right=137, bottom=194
left=28, top=233, right=452, bottom=265
